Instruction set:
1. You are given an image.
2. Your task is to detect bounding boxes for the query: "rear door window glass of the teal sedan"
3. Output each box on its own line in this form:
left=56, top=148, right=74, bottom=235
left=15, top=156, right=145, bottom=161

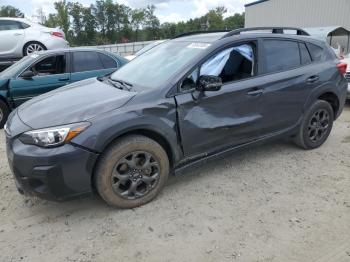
left=73, top=51, right=104, bottom=72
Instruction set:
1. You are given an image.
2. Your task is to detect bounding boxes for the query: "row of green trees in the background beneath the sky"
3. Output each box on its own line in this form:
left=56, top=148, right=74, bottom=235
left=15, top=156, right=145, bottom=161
left=0, top=0, right=244, bottom=46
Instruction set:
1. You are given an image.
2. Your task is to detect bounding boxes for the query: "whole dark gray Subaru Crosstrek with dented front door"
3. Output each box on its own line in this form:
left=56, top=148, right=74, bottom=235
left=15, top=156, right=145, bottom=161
left=5, top=28, right=347, bottom=208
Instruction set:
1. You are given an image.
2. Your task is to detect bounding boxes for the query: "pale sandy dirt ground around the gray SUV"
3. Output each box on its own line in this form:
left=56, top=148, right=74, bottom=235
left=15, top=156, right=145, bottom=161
left=0, top=104, right=350, bottom=262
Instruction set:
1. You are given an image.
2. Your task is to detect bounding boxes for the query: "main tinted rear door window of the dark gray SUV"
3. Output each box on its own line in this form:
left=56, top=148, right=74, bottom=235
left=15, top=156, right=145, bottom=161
left=263, top=40, right=300, bottom=73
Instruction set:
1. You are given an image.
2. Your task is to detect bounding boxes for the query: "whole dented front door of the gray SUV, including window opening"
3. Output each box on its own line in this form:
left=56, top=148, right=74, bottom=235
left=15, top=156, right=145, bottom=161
left=175, top=42, right=262, bottom=156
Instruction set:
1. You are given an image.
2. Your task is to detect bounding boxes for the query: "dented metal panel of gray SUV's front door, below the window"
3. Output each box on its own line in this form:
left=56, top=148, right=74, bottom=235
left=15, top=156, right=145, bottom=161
left=176, top=77, right=262, bottom=156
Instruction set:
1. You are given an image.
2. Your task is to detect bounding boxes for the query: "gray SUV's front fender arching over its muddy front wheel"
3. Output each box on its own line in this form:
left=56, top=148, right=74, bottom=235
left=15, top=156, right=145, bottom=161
left=72, top=99, right=182, bottom=163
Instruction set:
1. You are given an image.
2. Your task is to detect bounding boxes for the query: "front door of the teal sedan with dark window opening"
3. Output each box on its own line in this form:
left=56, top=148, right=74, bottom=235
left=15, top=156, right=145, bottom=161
left=10, top=53, right=70, bottom=106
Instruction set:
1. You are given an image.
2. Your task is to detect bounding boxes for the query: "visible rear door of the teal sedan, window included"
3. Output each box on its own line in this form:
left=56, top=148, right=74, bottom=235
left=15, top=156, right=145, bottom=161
left=71, top=51, right=118, bottom=82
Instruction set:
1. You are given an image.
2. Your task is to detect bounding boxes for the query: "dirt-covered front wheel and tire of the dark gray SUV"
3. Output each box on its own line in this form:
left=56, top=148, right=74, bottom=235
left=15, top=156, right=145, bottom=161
left=95, top=135, right=169, bottom=208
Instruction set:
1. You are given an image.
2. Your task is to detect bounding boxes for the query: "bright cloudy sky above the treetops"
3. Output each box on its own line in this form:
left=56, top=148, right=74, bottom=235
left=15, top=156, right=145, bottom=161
left=0, top=0, right=253, bottom=23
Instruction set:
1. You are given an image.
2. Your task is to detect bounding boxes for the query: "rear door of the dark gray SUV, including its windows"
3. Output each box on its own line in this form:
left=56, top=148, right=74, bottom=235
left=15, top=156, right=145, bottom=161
left=260, top=39, right=319, bottom=136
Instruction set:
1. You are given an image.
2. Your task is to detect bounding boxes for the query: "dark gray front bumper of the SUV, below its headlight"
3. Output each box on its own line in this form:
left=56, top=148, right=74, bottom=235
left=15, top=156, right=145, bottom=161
left=6, top=137, right=98, bottom=201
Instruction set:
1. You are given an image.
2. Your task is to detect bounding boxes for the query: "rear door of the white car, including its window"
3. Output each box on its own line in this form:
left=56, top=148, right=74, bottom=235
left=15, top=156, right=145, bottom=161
left=0, top=20, right=24, bottom=58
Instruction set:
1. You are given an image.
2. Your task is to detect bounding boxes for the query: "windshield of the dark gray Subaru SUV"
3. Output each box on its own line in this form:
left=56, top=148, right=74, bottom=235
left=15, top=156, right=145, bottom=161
left=111, top=41, right=210, bottom=88
